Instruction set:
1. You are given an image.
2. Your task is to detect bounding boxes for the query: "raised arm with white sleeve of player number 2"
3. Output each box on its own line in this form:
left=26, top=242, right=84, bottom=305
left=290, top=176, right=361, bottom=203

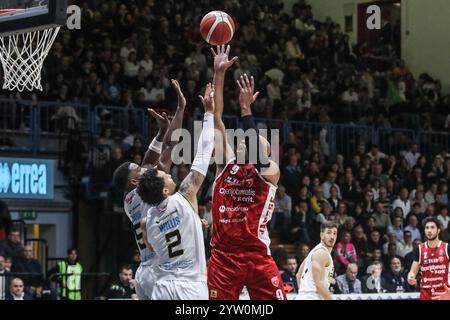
left=178, top=83, right=214, bottom=210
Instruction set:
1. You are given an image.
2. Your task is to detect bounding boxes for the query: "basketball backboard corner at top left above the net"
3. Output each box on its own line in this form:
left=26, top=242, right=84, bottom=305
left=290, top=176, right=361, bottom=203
left=0, top=0, right=67, bottom=35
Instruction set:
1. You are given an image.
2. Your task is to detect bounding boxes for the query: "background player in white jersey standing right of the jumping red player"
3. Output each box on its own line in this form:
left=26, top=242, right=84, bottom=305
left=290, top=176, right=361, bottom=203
left=296, top=221, right=337, bottom=300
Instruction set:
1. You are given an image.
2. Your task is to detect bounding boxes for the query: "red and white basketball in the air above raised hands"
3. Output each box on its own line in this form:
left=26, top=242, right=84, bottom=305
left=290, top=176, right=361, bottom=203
left=200, top=11, right=234, bottom=46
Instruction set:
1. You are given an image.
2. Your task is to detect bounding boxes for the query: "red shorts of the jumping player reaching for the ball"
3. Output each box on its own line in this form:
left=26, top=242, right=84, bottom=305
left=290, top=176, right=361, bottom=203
left=208, top=248, right=286, bottom=300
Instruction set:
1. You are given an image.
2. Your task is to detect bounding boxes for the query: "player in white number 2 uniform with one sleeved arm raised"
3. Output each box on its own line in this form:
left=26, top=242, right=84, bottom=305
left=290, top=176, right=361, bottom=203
left=137, top=84, right=214, bottom=300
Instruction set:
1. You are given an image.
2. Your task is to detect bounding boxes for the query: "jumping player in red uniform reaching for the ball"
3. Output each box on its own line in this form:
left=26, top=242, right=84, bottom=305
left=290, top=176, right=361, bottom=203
left=208, top=46, right=286, bottom=300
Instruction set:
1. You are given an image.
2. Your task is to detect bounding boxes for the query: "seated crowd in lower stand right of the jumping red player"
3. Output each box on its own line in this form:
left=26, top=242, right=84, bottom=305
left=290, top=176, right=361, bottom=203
left=272, top=136, right=450, bottom=292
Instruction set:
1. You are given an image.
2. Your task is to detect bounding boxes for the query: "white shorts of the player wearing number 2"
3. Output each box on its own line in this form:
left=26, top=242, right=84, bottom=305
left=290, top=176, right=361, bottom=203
left=152, top=280, right=209, bottom=300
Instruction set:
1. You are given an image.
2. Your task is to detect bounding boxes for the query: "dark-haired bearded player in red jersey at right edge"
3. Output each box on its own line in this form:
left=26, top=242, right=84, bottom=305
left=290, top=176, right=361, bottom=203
left=408, top=217, right=450, bottom=300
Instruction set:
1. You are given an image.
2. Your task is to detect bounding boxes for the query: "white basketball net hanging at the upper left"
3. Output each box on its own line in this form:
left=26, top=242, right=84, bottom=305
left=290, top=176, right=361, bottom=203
left=0, top=27, right=60, bottom=92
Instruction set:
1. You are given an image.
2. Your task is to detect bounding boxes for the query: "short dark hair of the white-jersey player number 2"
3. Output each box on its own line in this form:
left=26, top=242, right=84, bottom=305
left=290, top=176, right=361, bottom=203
left=136, top=169, right=165, bottom=205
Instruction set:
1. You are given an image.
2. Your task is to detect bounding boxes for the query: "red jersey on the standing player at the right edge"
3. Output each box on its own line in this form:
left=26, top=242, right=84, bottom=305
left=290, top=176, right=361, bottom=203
left=419, top=241, right=450, bottom=300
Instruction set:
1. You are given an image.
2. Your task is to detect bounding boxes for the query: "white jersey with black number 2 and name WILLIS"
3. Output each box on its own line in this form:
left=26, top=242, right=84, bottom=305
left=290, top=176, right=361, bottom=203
left=146, top=192, right=206, bottom=281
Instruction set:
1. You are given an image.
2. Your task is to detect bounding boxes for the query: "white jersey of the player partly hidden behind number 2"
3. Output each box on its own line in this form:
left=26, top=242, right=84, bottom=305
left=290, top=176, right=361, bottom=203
left=123, top=189, right=156, bottom=266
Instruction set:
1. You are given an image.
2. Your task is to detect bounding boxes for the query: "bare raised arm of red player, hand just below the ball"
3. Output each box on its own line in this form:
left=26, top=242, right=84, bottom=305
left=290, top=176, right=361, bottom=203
left=211, top=45, right=238, bottom=175
